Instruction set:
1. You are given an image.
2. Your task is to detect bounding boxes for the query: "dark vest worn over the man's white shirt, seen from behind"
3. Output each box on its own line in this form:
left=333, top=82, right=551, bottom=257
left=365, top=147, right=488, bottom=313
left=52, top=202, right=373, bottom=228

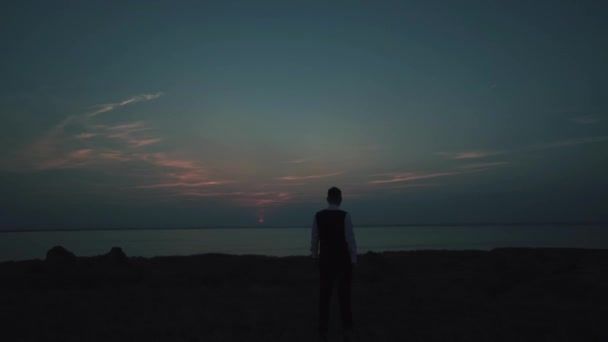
left=316, top=209, right=350, bottom=266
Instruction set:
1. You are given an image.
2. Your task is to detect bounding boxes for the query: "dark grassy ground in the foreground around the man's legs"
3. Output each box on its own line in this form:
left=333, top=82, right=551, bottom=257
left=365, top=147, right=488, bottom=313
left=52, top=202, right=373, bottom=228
left=0, top=249, right=608, bottom=342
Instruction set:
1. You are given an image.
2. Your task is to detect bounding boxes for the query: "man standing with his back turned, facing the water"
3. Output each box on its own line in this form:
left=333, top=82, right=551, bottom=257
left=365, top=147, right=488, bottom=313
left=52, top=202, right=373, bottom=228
left=310, top=187, right=357, bottom=341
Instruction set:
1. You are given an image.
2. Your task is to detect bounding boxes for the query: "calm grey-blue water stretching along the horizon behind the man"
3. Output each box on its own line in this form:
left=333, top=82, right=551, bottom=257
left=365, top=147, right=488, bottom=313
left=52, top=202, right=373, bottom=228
left=0, top=225, right=608, bottom=261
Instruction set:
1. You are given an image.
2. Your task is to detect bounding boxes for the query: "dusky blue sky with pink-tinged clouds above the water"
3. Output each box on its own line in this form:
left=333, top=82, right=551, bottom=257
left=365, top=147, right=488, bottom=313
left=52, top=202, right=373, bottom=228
left=0, top=0, right=608, bottom=230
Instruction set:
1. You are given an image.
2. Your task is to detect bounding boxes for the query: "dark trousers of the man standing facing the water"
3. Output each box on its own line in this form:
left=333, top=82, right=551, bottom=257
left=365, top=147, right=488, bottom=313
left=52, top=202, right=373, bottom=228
left=319, top=263, right=353, bottom=334
